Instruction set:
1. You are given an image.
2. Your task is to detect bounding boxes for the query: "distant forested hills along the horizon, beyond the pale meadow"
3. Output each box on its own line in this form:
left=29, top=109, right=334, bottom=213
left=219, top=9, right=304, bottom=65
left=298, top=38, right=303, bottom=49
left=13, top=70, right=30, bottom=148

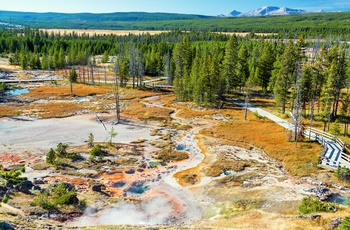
left=0, top=11, right=350, bottom=37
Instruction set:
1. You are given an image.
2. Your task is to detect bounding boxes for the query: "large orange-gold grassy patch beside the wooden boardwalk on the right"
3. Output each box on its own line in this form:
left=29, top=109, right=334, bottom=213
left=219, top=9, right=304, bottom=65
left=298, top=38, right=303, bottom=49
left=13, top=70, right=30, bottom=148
left=201, top=114, right=322, bottom=176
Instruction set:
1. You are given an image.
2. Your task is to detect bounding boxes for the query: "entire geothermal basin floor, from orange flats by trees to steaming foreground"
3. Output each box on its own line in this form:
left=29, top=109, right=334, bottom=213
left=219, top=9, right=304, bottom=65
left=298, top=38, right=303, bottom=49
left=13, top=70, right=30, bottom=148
left=0, top=70, right=348, bottom=229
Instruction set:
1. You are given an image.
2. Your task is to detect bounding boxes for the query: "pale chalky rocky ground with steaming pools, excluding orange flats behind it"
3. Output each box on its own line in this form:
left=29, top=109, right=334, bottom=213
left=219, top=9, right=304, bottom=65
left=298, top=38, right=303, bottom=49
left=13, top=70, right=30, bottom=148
left=0, top=73, right=349, bottom=229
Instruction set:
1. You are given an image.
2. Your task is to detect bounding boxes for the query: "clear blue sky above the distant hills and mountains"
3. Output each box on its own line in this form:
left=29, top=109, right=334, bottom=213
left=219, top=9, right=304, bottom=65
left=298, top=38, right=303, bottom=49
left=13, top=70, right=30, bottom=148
left=0, top=0, right=350, bottom=15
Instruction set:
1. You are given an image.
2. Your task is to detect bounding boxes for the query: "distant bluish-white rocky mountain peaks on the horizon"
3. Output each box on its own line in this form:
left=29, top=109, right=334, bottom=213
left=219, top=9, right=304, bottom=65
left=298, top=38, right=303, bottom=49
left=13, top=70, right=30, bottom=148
left=221, top=6, right=322, bottom=17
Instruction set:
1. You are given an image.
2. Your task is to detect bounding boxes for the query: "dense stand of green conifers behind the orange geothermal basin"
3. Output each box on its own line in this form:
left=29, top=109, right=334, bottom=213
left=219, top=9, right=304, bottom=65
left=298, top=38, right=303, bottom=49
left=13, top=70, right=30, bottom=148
left=0, top=28, right=350, bottom=134
